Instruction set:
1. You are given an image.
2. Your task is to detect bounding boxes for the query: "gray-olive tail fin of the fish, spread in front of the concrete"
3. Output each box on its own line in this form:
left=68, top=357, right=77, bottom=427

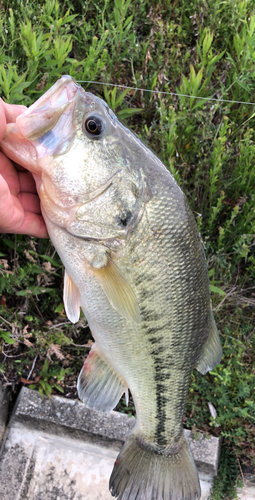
left=109, top=435, right=201, bottom=500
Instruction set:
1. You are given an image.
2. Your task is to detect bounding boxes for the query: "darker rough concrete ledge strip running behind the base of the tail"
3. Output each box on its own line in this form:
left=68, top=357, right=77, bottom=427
left=12, top=387, right=221, bottom=480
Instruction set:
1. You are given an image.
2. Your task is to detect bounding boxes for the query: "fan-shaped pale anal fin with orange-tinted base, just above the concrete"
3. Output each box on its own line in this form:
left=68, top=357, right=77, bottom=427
left=77, top=344, right=127, bottom=412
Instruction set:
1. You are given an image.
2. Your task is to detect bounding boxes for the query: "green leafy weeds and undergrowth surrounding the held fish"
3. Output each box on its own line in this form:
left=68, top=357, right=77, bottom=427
left=0, top=0, right=255, bottom=494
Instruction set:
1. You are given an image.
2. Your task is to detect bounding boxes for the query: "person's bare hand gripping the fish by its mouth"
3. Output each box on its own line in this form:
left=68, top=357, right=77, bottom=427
left=0, top=99, right=48, bottom=238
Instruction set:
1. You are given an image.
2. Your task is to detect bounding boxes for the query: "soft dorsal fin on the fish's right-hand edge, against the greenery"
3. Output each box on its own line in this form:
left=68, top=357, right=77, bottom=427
left=196, top=318, right=222, bottom=375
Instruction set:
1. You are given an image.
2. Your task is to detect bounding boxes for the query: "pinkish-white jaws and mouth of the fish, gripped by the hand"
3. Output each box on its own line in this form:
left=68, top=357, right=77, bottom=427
left=0, top=75, right=81, bottom=175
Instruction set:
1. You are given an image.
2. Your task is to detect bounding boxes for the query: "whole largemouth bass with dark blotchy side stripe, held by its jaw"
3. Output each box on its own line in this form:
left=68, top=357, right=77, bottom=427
left=1, top=76, right=222, bottom=500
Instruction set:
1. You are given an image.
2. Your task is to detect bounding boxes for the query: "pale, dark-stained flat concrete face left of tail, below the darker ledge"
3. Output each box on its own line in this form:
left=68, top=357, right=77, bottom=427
left=0, top=423, right=113, bottom=500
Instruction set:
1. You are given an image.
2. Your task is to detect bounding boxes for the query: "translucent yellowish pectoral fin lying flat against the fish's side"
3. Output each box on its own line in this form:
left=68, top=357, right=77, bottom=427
left=93, top=257, right=140, bottom=323
